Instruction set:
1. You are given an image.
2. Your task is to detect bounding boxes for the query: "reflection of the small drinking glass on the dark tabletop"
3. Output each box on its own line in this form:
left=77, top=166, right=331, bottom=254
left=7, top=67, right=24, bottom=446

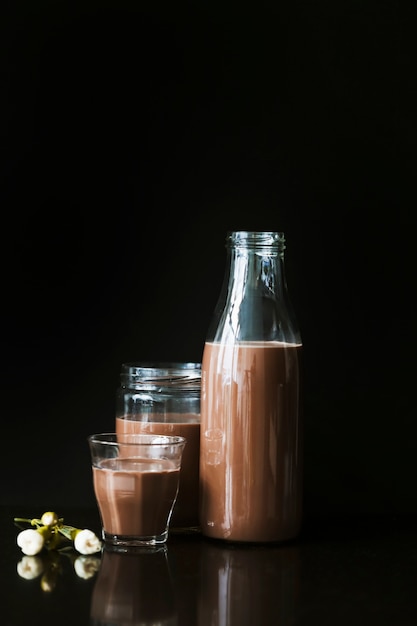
left=90, top=546, right=178, bottom=626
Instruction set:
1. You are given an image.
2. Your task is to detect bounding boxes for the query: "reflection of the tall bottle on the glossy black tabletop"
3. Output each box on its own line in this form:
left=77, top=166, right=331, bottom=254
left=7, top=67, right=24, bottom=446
left=198, top=542, right=299, bottom=626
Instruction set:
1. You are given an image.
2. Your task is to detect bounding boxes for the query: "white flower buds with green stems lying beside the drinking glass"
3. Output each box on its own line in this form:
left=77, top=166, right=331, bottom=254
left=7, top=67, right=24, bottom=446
left=14, top=511, right=102, bottom=556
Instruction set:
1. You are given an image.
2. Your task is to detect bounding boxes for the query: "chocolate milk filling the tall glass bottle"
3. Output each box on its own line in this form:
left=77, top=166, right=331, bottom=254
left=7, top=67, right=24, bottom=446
left=200, top=341, right=302, bottom=542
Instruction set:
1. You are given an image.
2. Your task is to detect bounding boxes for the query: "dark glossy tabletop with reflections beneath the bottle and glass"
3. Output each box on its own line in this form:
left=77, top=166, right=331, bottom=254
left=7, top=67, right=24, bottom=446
left=0, top=507, right=417, bottom=626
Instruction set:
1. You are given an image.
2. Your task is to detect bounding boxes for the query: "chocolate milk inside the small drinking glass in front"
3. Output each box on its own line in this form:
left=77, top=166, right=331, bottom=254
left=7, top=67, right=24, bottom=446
left=93, top=457, right=179, bottom=537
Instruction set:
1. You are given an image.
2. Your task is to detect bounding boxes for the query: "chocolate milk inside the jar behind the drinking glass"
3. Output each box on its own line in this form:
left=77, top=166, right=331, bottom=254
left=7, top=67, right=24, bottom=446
left=116, top=413, right=200, bottom=528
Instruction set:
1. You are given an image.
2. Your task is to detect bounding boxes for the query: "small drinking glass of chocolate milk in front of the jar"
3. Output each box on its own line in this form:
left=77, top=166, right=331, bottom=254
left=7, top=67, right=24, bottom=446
left=88, top=433, right=186, bottom=551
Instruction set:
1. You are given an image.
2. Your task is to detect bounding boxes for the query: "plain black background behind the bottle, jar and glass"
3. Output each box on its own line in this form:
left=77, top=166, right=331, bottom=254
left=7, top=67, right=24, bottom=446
left=0, top=0, right=417, bottom=515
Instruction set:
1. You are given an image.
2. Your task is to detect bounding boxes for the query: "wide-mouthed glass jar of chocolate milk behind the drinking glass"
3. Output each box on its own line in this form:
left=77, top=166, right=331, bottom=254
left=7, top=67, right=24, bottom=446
left=116, top=362, right=201, bottom=530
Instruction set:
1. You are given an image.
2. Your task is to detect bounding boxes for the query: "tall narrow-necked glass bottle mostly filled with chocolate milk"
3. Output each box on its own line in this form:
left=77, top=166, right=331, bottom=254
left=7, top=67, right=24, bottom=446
left=200, top=231, right=302, bottom=543
